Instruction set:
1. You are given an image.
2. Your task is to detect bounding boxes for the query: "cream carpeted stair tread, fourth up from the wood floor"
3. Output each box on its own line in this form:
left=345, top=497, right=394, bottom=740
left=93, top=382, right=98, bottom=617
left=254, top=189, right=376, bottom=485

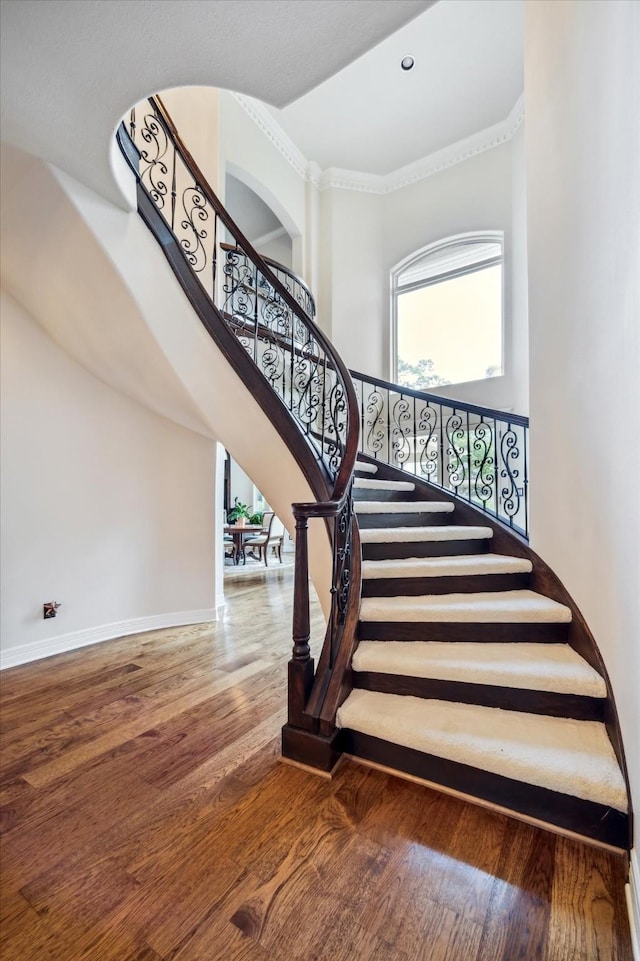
left=362, top=554, right=533, bottom=580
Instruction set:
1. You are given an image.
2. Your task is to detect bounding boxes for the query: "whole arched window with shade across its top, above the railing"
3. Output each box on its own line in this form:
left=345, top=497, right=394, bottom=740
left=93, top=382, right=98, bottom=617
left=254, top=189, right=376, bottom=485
left=391, top=231, right=503, bottom=390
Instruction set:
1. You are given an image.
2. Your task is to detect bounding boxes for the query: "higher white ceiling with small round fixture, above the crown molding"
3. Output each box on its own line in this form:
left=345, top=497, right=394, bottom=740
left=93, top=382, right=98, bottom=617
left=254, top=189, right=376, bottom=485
left=270, top=0, right=524, bottom=174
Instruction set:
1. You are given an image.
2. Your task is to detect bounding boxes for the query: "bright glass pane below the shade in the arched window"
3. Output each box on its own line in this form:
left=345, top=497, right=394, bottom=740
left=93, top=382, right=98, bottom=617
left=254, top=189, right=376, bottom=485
left=397, top=262, right=502, bottom=388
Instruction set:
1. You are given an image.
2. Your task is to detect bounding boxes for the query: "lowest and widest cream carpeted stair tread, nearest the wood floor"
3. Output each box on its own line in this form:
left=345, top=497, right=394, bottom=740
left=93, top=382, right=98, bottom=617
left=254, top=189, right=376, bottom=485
left=337, top=690, right=627, bottom=812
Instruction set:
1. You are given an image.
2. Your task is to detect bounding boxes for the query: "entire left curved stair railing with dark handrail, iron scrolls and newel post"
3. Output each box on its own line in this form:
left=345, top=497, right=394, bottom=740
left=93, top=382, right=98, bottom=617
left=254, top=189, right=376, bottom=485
left=117, top=97, right=359, bottom=733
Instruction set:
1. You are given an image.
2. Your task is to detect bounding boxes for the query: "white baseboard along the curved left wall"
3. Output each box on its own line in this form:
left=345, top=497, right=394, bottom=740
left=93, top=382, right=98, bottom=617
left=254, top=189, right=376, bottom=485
left=0, top=601, right=224, bottom=670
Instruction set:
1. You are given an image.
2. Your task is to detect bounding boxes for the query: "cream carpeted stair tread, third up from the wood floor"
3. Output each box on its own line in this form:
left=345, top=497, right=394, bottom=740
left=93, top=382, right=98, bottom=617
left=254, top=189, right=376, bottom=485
left=360, top=590, right=571, bottom=624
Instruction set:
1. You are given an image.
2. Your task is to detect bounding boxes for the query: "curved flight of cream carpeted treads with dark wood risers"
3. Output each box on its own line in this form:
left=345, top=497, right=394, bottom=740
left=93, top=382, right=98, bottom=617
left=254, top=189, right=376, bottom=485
left=337, top=459, right=628, bottom=847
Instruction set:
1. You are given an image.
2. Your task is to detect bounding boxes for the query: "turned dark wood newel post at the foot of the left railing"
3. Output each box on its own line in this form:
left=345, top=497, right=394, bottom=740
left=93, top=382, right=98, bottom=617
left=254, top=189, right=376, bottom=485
left=289, top=509, right=313, bottom=727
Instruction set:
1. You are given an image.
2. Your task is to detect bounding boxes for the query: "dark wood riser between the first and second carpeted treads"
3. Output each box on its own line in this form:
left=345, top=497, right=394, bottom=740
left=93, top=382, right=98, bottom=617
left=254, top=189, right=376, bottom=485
left=353, top=671, right=606, bottom=721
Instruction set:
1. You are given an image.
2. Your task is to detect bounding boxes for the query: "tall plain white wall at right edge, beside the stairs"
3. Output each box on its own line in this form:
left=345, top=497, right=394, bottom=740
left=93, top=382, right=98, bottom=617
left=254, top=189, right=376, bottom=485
left=525, top=0, right=640, bottom=840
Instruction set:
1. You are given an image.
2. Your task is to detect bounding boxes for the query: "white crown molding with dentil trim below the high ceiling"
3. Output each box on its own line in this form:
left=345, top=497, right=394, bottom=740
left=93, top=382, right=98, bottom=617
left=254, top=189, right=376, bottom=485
left=232, top=93, right=524, bottom=194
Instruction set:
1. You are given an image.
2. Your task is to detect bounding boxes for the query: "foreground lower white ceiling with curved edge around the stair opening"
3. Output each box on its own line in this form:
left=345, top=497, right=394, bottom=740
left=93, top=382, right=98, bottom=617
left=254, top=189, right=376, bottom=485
left=0, top=0, right=433, bottom=203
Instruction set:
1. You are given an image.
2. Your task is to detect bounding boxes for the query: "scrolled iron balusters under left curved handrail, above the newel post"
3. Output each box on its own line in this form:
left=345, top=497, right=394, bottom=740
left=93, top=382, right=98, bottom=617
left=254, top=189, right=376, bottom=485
left=120, top=103, right=342, bottom=481
